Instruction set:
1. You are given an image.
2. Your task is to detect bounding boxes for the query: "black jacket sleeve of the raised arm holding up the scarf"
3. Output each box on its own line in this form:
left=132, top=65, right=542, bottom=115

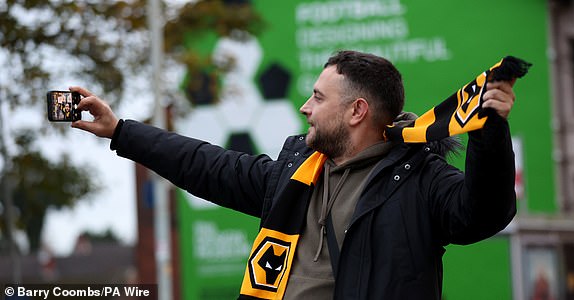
left=429, top=114, right=516, bottom=244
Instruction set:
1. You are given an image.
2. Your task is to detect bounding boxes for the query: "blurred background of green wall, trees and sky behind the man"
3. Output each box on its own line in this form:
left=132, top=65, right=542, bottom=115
left=0, top=0, right=574, bottom=300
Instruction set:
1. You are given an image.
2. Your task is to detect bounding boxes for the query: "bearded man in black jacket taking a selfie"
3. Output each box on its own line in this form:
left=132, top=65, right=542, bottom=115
left=71, top=51, right=516, bottom=299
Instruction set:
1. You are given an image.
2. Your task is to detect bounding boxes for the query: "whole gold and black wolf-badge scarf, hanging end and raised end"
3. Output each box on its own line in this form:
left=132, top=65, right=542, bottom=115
left=239, top=56, right=530, bottom=299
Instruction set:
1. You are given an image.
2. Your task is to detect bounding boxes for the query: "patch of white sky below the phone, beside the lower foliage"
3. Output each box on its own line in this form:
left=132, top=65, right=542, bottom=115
left=42, top=128, right=137, bottom=255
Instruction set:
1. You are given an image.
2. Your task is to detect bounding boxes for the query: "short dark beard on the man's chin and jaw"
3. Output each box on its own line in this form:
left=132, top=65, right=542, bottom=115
left=307, top=121, right=349, bottom=159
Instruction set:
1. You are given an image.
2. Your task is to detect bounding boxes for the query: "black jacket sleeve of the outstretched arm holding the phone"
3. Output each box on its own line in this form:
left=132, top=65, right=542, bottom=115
left=111, top=120, right=275, bottom=217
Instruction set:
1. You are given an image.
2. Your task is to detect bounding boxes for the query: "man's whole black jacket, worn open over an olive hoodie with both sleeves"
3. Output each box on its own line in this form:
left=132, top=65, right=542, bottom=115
left=111, top=116, right=516, bottom=299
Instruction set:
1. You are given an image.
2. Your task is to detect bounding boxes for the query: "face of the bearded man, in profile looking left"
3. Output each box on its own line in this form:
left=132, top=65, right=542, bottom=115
left=300, top=66, right=349, bottom=159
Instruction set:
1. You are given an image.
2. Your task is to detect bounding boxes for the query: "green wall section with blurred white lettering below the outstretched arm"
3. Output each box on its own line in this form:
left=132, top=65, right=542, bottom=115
left=177, top=192, right=258, bottom=300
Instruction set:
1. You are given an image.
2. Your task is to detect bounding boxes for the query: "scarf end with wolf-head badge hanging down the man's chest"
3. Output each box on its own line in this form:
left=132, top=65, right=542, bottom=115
left=239, top=152, right=327, bottom=299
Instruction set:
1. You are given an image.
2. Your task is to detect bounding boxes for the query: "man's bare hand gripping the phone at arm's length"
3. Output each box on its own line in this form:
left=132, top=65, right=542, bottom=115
left=70, top=86, right=119, bottom=138
